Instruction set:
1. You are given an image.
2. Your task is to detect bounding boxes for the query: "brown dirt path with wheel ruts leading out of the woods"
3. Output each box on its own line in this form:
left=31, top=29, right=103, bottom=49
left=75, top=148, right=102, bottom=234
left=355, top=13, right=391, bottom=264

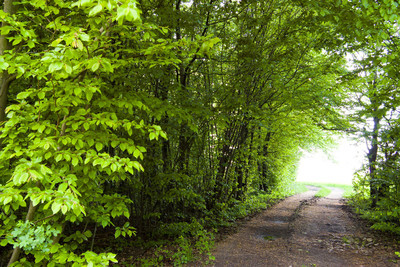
left=213, top=187, right=400, bottom=267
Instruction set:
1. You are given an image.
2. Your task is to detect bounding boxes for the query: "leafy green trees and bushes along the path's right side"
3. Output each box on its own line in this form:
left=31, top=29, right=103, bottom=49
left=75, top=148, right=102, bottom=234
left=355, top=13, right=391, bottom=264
left=340, top=1, right=400, bottom=237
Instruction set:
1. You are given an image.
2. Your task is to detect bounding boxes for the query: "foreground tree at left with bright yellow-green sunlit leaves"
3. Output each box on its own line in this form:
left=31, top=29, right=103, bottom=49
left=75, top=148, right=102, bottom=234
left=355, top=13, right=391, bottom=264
left=0, top=1, right=169, bottom=265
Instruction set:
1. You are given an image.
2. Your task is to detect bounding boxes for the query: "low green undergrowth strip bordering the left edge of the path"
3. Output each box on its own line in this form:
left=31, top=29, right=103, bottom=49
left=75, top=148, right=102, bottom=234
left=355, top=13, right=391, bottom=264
left=124, top=183, right=308, bottom=266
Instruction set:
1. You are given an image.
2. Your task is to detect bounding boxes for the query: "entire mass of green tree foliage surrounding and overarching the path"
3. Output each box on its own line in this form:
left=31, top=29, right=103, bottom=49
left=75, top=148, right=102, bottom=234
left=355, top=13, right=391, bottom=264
left=0, top=0, right=400, bottom=266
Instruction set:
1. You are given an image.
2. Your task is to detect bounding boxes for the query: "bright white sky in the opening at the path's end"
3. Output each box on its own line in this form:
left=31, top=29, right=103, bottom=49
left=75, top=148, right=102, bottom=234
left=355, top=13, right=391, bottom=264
left=297, top=138, right=366, bottom=184
